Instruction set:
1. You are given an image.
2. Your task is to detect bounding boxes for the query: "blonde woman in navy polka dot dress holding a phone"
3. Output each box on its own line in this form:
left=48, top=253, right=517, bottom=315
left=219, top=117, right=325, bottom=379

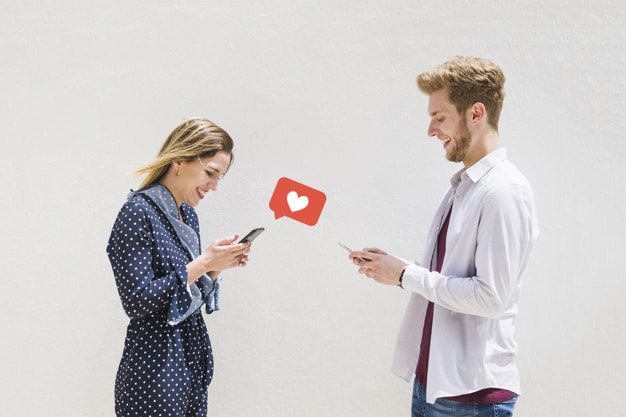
left=107, top=118, right=250, bottom=417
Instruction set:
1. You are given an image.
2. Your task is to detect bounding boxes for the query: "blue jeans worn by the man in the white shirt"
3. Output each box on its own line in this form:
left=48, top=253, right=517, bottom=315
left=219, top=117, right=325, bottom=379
left=411, top=379, right=517, bottom=417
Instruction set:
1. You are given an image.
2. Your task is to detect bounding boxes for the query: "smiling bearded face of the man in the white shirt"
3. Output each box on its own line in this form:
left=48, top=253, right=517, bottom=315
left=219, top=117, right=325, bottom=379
left=428, top=88, right=472, bottom=162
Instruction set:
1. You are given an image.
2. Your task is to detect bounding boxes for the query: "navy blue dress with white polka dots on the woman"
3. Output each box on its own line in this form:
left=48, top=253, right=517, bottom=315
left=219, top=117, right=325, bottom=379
left=107, top=186, right=213, bottom=417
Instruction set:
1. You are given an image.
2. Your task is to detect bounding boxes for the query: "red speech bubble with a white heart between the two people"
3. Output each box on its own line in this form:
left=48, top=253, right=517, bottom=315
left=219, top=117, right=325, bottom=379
left=270, top=177, right=326, bottom=226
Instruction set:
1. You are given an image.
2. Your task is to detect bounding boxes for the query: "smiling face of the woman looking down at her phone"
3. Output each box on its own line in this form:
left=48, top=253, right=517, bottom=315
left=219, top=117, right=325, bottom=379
left=170, top=151, right=230, bottom=207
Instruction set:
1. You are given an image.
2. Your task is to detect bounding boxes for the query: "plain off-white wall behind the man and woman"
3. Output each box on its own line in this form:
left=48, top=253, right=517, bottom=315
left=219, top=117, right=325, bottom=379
left=0, top=0, right=626, bottom=417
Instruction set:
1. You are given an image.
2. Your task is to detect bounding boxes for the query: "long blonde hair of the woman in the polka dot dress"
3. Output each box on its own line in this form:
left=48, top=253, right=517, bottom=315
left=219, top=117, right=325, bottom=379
left=135, top=117, right=234, bottom=188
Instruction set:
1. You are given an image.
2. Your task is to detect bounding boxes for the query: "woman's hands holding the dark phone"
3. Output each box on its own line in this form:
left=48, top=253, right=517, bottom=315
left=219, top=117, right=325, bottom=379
left=187, top=234, right=252, bottom=284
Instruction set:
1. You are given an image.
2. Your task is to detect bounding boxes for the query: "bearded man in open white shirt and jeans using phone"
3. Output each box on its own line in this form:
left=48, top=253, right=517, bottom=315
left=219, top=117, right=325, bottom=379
left=350, top=57, right=538, bottom=417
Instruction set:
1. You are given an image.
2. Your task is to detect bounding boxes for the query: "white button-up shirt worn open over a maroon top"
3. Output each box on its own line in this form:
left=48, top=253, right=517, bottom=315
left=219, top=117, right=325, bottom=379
left=392, top=148, right=539, bottom=403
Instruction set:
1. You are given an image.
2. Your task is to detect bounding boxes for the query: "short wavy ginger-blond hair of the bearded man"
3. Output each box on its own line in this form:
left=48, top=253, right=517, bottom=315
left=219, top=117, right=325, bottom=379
left=417, top=56, right=505, bottom=130
